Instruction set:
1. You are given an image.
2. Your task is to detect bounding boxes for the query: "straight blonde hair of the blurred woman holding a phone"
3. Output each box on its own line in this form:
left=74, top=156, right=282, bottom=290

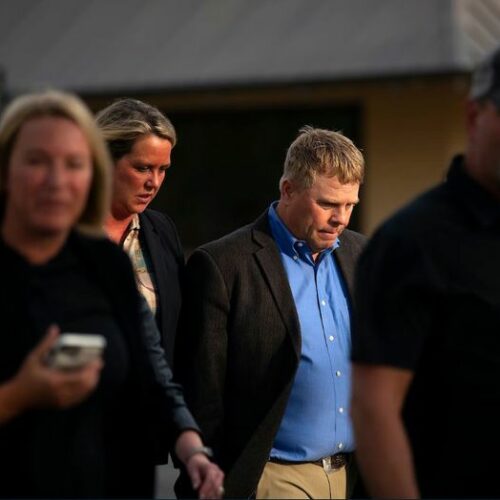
left=0, top=90, right=112, bottom=234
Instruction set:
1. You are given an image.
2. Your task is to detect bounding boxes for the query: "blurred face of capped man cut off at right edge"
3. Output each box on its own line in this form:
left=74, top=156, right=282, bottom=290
left=467, top=101, right=500, bottom=196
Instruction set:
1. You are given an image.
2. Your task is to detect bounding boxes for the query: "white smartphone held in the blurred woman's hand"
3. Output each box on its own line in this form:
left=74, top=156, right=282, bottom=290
left=46, top=333, right=106, bottom=370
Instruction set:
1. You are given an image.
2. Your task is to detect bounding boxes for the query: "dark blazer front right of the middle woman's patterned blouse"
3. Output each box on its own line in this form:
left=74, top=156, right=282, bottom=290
left=139, top=209, right=184, bottom=366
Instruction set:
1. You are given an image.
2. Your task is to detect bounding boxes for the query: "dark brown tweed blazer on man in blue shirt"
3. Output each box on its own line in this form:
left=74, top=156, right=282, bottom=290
left=175, top=212, right=365, bottom=498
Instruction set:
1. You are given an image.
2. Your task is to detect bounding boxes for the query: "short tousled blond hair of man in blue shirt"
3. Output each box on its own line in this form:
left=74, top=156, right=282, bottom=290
left=280, top=126, right=365, bottom=189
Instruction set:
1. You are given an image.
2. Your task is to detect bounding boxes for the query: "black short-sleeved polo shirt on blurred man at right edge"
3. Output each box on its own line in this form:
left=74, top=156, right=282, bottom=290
left=352, top=156, right=500, bottom=497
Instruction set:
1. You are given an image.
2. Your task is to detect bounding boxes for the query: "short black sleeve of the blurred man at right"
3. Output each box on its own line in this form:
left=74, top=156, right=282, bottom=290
left=352, top=226, right=435, bottom=371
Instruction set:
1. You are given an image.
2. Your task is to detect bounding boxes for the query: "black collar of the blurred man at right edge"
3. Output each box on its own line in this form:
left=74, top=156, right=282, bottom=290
left=446, top=155, right=500, bottom=227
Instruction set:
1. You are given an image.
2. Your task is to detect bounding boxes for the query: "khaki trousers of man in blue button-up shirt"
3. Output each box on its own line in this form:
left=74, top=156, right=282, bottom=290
left=256, top=462, right=347, bottom=498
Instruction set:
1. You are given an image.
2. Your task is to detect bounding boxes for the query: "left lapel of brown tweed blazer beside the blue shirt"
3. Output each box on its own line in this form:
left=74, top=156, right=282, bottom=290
left=252, top=212, right=301, bottom=359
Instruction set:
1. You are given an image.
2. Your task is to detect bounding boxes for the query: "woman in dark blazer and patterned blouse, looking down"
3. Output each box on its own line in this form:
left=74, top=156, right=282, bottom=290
left=96, top=99, right=184, bottom=365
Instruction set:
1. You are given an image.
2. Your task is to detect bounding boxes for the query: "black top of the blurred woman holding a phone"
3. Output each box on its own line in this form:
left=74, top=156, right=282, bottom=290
left=0, top=233, right=195, bottom=497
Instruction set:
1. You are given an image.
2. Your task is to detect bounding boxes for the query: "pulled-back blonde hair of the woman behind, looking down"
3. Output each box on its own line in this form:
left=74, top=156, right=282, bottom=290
left=96, top=99, right=177, bottom=162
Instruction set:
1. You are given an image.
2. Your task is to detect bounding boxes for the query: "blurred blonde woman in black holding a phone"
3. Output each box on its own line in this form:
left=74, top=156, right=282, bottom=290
left=0, top=92, right=222, bottom=498
